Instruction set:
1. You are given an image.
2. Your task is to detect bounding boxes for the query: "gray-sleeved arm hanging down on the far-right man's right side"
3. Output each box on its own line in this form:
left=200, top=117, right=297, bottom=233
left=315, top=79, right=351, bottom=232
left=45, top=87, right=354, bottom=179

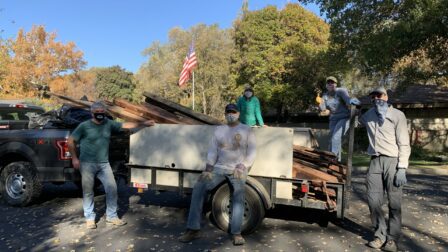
left=395, top=111, right=411, bottom=168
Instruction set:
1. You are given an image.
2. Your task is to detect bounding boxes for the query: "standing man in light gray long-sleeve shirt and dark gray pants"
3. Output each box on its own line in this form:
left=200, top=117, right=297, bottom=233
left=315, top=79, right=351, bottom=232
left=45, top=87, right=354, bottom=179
left=360, top=87, right=411, bottom=251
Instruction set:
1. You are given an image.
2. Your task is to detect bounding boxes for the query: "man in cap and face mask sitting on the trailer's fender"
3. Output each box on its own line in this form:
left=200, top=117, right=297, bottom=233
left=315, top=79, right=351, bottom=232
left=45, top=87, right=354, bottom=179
left=179, top=104, right=256, bottom=245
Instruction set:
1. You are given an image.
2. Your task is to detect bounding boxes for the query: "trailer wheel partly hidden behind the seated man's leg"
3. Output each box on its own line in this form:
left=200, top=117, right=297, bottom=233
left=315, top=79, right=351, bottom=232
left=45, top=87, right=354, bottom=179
left=212, top=183, right=265, bottom=234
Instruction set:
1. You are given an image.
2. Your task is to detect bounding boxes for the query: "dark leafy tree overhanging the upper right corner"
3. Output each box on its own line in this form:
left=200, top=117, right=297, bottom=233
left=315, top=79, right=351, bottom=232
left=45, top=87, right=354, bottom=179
left=299, top=0, right=448, bottom=84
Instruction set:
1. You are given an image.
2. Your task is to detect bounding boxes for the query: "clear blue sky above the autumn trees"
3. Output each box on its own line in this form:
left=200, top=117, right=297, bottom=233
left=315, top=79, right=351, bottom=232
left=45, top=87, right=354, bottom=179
left=0, top=0, right=320, bottom=72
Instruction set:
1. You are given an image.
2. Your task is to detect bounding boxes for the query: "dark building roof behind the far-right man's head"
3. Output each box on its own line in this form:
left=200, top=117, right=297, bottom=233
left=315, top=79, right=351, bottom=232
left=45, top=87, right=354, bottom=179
left=360, top=85, right=448, bottom=108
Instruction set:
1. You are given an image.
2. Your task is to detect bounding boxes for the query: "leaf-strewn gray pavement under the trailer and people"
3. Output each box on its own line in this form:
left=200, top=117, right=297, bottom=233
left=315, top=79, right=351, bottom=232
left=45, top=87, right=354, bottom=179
left=0, top=169, right=448, bottom=251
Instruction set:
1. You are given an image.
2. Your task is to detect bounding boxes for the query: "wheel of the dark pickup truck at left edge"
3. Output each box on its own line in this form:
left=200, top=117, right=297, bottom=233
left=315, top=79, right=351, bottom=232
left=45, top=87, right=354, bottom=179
left=0, top=162, right=42, bottom=206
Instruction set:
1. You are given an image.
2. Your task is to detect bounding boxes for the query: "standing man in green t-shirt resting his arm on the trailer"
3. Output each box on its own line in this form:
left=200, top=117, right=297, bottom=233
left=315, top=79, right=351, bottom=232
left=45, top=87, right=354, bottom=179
left=68, top=102, right=155, bottom=229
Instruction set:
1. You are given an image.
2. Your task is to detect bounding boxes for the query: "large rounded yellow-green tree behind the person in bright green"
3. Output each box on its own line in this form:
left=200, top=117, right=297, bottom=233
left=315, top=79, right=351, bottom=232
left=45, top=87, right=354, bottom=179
left=234, top=4, right=329, bottom=115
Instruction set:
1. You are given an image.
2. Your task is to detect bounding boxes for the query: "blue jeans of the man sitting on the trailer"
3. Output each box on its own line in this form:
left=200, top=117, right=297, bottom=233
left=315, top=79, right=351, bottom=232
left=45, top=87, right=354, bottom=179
left=187, top=170, right=247, bottom=234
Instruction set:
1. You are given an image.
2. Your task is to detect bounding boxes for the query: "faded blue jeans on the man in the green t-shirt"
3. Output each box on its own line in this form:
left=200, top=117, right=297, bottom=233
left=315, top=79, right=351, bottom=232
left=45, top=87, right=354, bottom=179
left=80, top=162, right=118, bottom=220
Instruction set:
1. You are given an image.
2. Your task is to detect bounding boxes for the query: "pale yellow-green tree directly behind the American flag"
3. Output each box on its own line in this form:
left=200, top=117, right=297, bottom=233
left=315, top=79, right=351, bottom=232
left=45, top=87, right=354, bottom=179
left=136, top=24, right=234, bottom=117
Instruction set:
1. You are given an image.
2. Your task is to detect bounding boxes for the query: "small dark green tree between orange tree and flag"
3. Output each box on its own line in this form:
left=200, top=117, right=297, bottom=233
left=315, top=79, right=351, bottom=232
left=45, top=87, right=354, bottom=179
left=95, top=66, right=136, bottom=101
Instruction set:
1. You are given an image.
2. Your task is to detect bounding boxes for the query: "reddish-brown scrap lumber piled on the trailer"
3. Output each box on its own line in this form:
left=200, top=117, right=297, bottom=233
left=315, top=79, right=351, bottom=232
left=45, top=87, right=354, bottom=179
left=52, top=92, right=347, bottom=209
